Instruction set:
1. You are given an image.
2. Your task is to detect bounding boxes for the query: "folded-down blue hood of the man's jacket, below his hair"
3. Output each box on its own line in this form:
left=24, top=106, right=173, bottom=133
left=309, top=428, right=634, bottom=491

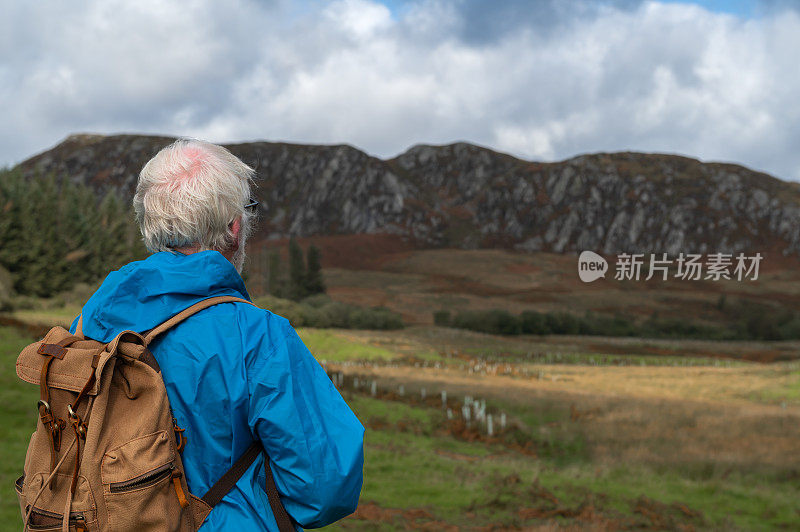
left=80, top=251, right=250, bottom=342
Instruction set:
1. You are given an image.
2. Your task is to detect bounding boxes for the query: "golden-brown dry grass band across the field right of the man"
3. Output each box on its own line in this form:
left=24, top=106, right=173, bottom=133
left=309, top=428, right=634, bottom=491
left=342, top=366, right=800, bottom=478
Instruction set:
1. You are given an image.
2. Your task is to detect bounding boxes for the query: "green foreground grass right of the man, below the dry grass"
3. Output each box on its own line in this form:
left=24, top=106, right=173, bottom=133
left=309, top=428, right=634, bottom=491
left=328, top=393, right=800, bottom=530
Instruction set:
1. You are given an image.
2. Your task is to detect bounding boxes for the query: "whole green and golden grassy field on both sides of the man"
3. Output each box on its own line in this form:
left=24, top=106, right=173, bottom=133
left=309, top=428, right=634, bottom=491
left=0, top=314, right=800, bottom=530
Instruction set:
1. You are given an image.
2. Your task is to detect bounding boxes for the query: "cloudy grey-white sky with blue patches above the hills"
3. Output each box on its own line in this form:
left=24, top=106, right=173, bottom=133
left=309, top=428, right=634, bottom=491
left=0, top=0, right=800, bottom=180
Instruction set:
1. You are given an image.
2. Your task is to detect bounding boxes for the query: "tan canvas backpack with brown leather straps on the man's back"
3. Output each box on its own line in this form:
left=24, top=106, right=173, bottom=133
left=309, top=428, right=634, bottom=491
left=15, top=296, right=295, bottom=532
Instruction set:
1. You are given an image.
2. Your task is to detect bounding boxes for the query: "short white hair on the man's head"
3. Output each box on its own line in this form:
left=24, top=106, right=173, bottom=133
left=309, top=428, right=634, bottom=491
left=133, top=139, right=254, bottom=271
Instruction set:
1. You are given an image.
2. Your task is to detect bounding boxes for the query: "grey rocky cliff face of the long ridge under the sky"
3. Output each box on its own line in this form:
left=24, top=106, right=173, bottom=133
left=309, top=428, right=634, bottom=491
left=19, top=135, right=800, bottom=255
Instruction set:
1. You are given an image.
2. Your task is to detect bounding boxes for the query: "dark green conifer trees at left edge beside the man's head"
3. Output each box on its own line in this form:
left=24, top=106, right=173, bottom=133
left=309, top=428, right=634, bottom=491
left=0, top=170, right=146, bottom=297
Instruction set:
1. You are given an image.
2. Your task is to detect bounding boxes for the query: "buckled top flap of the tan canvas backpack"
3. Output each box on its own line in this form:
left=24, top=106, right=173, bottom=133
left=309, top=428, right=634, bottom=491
left=17, top=327, right=113, bottom=395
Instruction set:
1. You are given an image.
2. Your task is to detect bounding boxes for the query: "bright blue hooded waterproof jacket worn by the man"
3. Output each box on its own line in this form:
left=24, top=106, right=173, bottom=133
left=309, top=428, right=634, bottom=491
left=71, top=251, right=364, bottom=532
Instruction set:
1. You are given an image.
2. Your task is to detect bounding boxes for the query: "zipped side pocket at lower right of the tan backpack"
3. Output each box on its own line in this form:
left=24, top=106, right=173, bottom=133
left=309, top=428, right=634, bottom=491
left=101, top=431, right=191, bottom=531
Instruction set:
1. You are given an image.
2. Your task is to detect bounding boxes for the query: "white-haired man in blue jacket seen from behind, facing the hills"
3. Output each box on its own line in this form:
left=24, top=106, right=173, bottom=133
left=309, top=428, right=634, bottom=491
left=71, top=140, right=364, bottom=532
